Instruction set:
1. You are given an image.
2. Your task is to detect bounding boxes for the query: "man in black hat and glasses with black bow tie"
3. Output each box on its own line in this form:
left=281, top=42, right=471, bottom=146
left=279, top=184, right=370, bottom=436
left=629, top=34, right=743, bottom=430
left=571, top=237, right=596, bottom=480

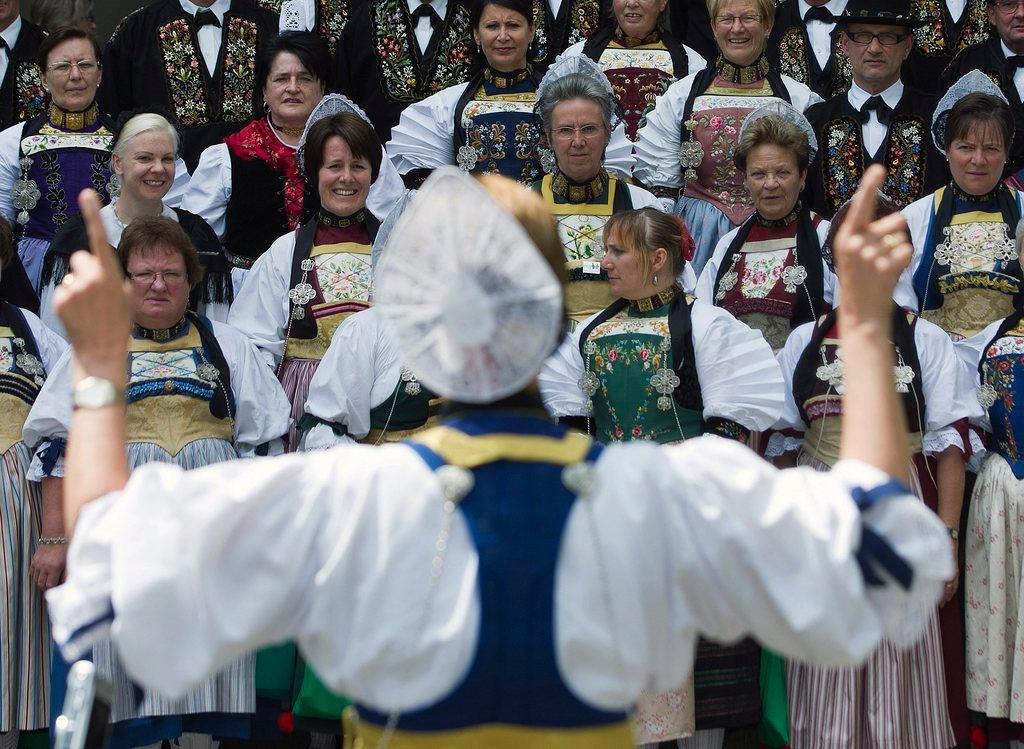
left=802, top=0, right=948, bottom=216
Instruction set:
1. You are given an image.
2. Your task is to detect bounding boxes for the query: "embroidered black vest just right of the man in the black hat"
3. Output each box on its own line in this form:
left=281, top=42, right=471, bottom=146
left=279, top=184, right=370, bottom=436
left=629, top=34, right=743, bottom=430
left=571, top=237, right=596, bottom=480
left=904, top=0, right=989, bottom=94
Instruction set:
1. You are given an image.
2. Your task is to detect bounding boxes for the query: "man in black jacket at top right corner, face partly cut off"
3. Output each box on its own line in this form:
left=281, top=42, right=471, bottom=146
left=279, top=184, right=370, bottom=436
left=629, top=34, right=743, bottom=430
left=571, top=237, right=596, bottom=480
left=941, top=0, right=1024, bottom=174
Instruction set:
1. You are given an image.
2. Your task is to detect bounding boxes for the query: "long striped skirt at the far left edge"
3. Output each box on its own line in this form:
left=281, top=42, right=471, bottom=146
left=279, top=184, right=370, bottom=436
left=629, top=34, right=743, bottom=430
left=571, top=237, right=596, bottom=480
left=0, top=442, right=50, bottom=734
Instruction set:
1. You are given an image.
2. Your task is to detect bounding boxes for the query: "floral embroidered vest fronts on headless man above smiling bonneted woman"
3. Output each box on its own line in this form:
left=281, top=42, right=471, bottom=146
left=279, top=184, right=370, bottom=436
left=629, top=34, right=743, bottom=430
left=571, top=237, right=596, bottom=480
left=372, top=0, right=472, bottom=101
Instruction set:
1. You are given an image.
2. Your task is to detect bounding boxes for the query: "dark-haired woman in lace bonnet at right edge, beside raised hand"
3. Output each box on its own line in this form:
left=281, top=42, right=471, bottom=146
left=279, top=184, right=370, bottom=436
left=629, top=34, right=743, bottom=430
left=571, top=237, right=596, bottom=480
left=896, top=71, right=1024, bottom=340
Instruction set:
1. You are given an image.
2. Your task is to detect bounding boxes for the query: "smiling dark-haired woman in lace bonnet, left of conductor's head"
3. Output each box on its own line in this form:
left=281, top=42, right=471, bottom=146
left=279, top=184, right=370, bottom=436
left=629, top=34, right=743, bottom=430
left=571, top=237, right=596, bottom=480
left=228, top=94, right=403, bottom=450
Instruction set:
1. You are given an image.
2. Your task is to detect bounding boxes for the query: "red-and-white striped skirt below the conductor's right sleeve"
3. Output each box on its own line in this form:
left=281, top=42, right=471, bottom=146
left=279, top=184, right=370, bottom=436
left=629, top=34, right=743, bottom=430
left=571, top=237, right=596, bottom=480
left=786, top=453, right=954, bottom=749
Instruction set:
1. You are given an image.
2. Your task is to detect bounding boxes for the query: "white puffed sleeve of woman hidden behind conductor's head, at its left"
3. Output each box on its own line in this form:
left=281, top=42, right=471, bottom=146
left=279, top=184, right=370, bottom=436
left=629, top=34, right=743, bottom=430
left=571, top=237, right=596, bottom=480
left=303, top=307, right=401, bottom=450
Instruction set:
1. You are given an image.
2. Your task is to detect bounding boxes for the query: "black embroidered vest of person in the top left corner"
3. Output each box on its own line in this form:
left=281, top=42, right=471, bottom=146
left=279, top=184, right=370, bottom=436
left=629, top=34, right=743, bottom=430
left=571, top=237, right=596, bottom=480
left=0, top=15, right=50, bottom=130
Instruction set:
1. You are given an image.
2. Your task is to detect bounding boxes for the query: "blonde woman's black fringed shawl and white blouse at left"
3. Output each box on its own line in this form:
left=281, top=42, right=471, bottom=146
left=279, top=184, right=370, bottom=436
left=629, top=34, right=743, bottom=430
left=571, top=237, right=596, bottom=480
left=39, top=202, right=233, bottom=335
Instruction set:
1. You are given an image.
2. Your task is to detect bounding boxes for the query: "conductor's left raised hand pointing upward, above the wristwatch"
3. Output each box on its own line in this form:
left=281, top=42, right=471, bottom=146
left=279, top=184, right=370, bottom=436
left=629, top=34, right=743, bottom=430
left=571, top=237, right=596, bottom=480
left=53, top=190, right=131, bottom=384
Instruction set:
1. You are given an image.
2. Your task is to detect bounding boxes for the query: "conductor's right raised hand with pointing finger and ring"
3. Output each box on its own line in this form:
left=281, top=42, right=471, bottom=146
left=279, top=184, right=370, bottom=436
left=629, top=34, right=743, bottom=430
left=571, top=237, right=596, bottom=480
left=833, top=164, right=913, bottom=322
